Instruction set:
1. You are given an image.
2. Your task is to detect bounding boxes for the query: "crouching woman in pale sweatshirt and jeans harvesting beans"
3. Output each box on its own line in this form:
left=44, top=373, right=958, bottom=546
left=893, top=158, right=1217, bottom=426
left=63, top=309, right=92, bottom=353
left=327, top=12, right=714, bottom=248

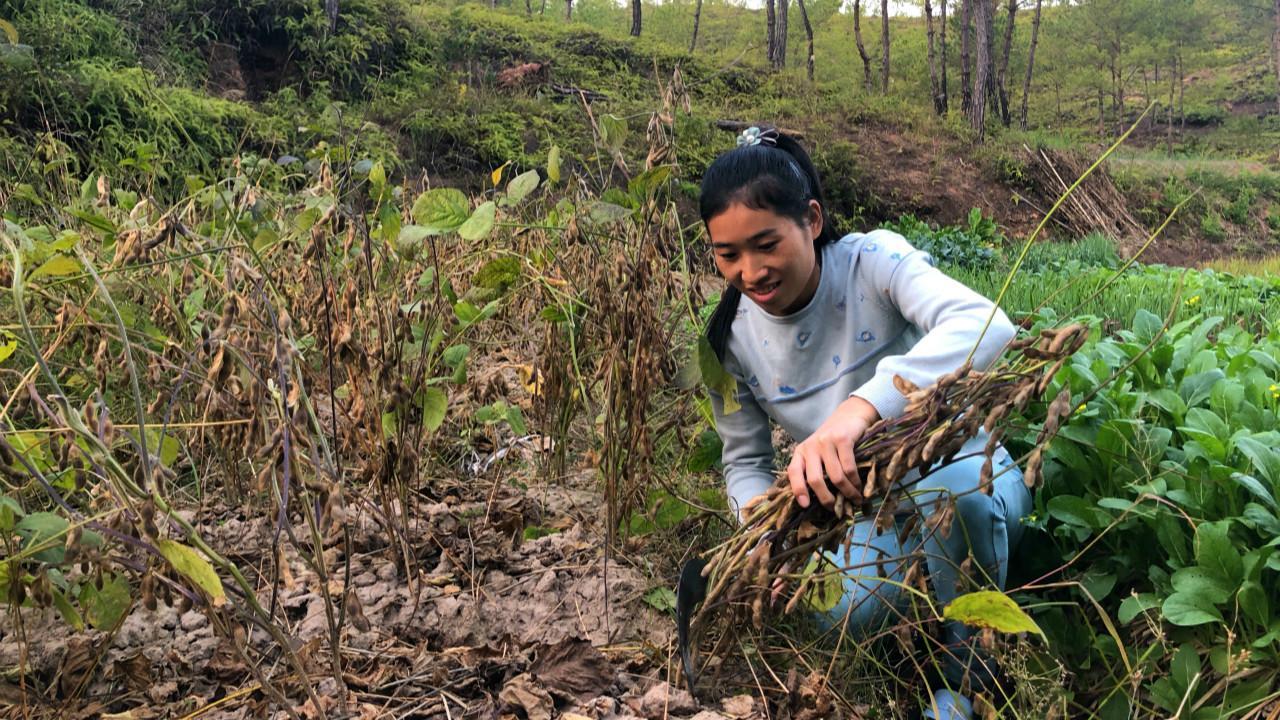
left=700, top=127, right=1030, bottom=720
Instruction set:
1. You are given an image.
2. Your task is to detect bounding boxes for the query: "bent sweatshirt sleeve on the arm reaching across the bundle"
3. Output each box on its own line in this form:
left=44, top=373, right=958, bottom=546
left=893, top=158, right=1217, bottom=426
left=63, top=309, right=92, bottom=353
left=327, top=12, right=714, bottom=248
left=850, top=231, right=1015, bottom=418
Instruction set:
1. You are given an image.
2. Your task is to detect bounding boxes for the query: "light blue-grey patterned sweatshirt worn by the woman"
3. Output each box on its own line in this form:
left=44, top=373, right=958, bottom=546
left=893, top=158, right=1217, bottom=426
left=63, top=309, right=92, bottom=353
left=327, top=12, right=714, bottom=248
left=712, top=229, right=1014, bottom=512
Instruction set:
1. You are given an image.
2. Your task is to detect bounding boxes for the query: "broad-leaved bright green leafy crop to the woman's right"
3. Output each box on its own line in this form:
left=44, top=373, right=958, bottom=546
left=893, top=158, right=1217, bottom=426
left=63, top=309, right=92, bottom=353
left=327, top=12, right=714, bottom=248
left=1020, top=310, right=1280, bottom=711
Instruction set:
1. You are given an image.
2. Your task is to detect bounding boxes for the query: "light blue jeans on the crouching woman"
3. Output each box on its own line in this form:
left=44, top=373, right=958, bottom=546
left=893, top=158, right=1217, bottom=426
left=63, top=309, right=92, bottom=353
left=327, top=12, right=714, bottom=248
left=819, top=457, right=1032, bottom=642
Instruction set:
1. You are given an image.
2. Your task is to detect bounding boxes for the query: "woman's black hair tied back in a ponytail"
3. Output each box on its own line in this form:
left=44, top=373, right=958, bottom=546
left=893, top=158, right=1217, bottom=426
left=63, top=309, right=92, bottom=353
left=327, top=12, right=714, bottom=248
left=699, top=126, right=840, bottom=363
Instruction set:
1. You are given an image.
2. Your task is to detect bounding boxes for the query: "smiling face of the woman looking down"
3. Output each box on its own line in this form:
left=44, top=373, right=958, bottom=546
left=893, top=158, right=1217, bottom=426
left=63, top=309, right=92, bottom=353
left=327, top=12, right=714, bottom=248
left=707, top=200, right=822, bottom=315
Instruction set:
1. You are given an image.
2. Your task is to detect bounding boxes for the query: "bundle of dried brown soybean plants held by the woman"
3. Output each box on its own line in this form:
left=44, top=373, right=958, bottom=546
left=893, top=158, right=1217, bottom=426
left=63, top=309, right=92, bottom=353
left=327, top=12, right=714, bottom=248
left=694, top=324, right=1088, bottom=626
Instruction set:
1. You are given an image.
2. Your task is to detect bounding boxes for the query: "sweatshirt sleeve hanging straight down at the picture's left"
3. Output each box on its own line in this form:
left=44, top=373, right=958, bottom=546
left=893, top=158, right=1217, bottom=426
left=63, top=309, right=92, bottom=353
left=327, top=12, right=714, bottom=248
left=710, top=353, right=773, bottom=520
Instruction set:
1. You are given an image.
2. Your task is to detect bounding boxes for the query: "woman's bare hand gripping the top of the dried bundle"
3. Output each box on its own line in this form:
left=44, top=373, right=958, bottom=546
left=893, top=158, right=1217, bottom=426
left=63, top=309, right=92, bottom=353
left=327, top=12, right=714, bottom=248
left=787, top=396, right=879, bottom=509
